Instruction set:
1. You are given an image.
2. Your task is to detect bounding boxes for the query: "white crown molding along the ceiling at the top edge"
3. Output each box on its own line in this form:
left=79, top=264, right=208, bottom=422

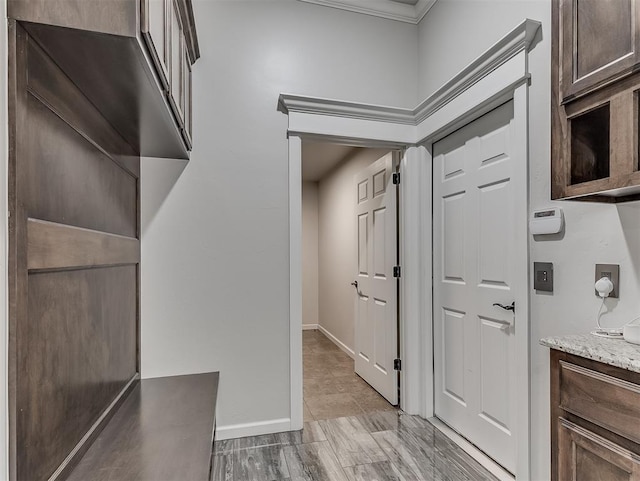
left=299, top=0, right=437, bottom=25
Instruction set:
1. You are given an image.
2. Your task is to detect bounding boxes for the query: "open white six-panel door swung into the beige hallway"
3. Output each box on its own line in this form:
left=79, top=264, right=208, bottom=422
left=354, top=153, right=398, bottom=404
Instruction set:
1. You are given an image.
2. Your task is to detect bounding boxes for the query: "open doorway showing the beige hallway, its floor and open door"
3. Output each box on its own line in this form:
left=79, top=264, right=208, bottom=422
left=301, top=140, right=399, bottom=422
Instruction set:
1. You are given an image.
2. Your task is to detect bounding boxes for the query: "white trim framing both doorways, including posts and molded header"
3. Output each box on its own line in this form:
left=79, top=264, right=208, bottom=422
left=278, top=19, right=541, bottom=479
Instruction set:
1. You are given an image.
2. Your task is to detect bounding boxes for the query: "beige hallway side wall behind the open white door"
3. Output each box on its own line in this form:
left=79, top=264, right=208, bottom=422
left=318, top=149, right=389, bottom=351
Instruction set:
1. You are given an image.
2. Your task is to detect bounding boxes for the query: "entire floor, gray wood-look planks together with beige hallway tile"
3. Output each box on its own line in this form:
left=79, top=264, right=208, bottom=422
left=212, top=331, right=496, bottom=481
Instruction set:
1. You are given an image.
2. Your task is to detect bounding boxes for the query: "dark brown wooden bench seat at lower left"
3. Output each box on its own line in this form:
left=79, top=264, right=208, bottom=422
left=68, top=372, right=218, bottom=481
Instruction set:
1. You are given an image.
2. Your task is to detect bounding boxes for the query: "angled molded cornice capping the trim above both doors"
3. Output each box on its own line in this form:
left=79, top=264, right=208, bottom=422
left=278, top=19, right=542, bottom=126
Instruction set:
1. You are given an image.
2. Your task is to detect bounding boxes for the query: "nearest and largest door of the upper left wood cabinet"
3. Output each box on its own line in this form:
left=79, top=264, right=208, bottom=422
left=141, top=0, right=169, bottom=89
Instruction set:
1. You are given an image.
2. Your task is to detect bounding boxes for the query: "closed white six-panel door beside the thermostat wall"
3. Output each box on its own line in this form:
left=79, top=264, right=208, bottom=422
left=433, top=101, right=527, bottom=472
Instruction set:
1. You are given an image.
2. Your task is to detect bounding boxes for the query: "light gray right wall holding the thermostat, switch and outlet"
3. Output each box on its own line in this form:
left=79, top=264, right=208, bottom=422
left=419, top=0, right=640, bottom=481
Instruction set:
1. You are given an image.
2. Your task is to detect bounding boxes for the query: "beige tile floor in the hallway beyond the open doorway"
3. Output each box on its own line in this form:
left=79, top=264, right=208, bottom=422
left=302, top=331, right=396, bottom=422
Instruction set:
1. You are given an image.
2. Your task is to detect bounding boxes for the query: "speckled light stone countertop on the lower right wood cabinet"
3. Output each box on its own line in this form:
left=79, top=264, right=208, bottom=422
left=540, top=334, right=640, bottom=373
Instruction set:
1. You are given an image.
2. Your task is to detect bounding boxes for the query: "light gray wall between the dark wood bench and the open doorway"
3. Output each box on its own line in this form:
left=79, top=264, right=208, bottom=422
left=141, top=0, right=418, bottom=436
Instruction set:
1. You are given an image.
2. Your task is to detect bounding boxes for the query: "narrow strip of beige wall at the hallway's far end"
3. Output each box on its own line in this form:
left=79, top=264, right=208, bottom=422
left=302, top=182, right=318, bottom=326
